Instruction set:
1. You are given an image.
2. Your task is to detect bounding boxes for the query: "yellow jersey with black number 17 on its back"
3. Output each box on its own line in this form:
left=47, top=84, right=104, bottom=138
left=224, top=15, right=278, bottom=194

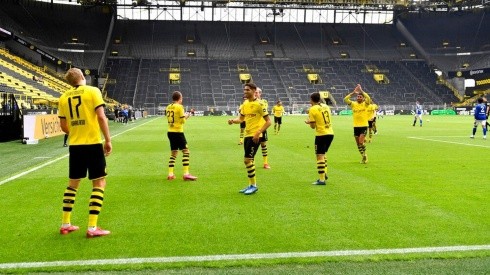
left=58, top=85, right=105, bottom=145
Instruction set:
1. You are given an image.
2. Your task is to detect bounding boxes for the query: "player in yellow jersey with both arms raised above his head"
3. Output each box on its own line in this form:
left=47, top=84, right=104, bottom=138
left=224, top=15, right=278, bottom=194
left=344, top=84, right=371, bottom=163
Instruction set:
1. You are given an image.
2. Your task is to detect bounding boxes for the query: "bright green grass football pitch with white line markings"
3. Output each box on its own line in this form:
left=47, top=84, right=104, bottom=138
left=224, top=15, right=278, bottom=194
left=0, top=116, right=490, bottom=274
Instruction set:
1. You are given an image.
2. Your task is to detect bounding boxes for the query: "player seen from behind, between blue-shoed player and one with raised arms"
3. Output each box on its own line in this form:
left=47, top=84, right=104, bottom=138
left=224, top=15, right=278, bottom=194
left=305, top=92, right=334, bottom=185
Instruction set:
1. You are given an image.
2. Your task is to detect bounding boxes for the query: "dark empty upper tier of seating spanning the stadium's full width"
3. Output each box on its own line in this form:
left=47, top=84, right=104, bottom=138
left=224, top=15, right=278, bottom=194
left=0, top=0, right=490, bottom=71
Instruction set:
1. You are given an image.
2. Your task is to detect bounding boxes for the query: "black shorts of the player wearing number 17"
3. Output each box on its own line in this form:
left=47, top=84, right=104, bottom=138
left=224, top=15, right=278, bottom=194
left=68, top=144, right=107, bottom=180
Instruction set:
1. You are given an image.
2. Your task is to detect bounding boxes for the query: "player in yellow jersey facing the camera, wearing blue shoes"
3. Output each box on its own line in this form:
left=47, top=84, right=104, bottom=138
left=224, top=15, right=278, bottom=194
left=228, top=83, right=271, bottom=195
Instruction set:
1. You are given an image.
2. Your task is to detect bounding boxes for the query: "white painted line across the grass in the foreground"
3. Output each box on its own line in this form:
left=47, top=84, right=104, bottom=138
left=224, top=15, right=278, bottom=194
left=0, top=245, right=490, bottom=269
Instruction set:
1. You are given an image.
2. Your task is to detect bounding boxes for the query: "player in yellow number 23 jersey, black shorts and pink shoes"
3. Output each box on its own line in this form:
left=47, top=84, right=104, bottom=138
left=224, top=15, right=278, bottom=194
left=165, top=91, right=197, bottom=181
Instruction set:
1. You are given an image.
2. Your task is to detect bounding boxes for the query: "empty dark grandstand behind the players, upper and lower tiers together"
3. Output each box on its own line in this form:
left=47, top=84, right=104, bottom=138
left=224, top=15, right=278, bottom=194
left=0, top=1, right=490, bottom=115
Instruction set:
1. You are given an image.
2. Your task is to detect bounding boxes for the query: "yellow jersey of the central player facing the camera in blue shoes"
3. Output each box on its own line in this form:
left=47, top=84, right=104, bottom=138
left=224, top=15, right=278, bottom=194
left=240, top=99, right=269, bottom=137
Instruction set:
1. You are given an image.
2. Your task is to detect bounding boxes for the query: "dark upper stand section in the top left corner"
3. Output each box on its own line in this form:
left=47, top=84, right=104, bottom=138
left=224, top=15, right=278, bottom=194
left=0, top=1, right=111, bottom=68
